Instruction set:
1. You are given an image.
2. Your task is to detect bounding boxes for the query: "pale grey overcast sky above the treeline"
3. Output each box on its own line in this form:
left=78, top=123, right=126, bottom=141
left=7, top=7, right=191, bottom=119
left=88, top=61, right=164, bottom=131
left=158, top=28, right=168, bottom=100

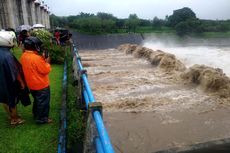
left=44, top=0, right=230, bottom=19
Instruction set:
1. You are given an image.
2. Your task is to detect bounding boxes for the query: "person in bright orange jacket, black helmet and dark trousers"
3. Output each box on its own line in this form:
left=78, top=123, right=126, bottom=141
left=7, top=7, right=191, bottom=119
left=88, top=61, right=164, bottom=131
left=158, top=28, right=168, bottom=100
left=20, top=37, right=52, bottom=124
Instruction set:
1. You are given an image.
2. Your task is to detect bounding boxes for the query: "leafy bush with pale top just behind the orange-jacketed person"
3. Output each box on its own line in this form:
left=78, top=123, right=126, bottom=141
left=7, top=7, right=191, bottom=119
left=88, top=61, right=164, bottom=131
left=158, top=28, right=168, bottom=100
left=31, top=29, right=65, bottom=64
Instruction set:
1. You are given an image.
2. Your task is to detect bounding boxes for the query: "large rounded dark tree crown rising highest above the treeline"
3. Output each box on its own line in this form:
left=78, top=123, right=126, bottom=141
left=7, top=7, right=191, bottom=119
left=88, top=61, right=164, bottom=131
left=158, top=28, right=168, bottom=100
left=168, top=7, right=196, bottom=27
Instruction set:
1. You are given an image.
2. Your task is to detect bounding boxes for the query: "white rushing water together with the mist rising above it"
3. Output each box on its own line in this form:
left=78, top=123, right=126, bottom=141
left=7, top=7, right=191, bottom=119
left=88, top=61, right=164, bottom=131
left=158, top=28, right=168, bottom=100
left=143, top=36, right=230, bottom=76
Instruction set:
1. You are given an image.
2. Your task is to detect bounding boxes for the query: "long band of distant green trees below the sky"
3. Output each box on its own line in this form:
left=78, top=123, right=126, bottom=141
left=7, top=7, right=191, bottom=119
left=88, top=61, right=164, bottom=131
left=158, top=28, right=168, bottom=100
left=50, top=7, right=230, bottom=35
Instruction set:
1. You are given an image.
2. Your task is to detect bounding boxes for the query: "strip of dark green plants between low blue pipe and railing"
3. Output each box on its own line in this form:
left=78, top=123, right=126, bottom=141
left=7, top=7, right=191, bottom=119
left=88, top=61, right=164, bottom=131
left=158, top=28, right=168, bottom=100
left=67, top=47, right=86, bottom=153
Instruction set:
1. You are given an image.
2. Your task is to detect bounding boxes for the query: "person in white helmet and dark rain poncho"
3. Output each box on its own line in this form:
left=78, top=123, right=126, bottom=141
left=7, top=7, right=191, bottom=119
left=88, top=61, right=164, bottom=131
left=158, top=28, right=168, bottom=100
left=0, top=31, right=25, bottom=125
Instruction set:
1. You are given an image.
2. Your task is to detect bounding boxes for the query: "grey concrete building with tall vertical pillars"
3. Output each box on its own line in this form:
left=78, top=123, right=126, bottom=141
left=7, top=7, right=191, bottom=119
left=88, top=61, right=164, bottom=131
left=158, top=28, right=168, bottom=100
left=0, top=0, right=50, bottom=29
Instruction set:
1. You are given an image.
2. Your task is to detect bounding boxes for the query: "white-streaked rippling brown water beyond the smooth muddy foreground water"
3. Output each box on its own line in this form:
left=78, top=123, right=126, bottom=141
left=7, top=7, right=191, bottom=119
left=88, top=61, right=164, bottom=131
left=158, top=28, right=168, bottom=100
left=81, top=49, right=228, bottom=112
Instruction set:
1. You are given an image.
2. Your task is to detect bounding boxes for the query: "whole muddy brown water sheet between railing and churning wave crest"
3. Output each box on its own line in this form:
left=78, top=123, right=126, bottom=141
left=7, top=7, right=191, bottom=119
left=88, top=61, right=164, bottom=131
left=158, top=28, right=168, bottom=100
left=80, top=49, right=230, bottom=153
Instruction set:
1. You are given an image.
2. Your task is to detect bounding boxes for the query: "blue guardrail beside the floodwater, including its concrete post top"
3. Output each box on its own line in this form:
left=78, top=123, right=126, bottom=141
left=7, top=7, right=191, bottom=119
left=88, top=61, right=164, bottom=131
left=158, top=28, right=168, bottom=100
left=73, top=45, right=114, bottom=153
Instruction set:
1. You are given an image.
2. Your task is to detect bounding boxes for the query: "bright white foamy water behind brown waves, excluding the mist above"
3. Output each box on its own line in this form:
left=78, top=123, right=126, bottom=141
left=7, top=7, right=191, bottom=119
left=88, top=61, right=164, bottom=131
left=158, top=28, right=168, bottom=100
left=143, top=41, right=230, bottom=76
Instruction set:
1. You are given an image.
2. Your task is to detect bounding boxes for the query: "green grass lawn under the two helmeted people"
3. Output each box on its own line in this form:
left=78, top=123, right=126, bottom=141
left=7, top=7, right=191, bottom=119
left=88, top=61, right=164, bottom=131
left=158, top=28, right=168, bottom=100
left=0, top=48, right=63, bottom=153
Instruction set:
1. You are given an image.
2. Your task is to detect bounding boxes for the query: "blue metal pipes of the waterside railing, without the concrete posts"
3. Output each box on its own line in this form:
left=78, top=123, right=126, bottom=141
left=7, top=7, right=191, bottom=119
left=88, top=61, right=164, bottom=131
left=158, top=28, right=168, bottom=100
left=73, top=45, right=114, bottom=153
